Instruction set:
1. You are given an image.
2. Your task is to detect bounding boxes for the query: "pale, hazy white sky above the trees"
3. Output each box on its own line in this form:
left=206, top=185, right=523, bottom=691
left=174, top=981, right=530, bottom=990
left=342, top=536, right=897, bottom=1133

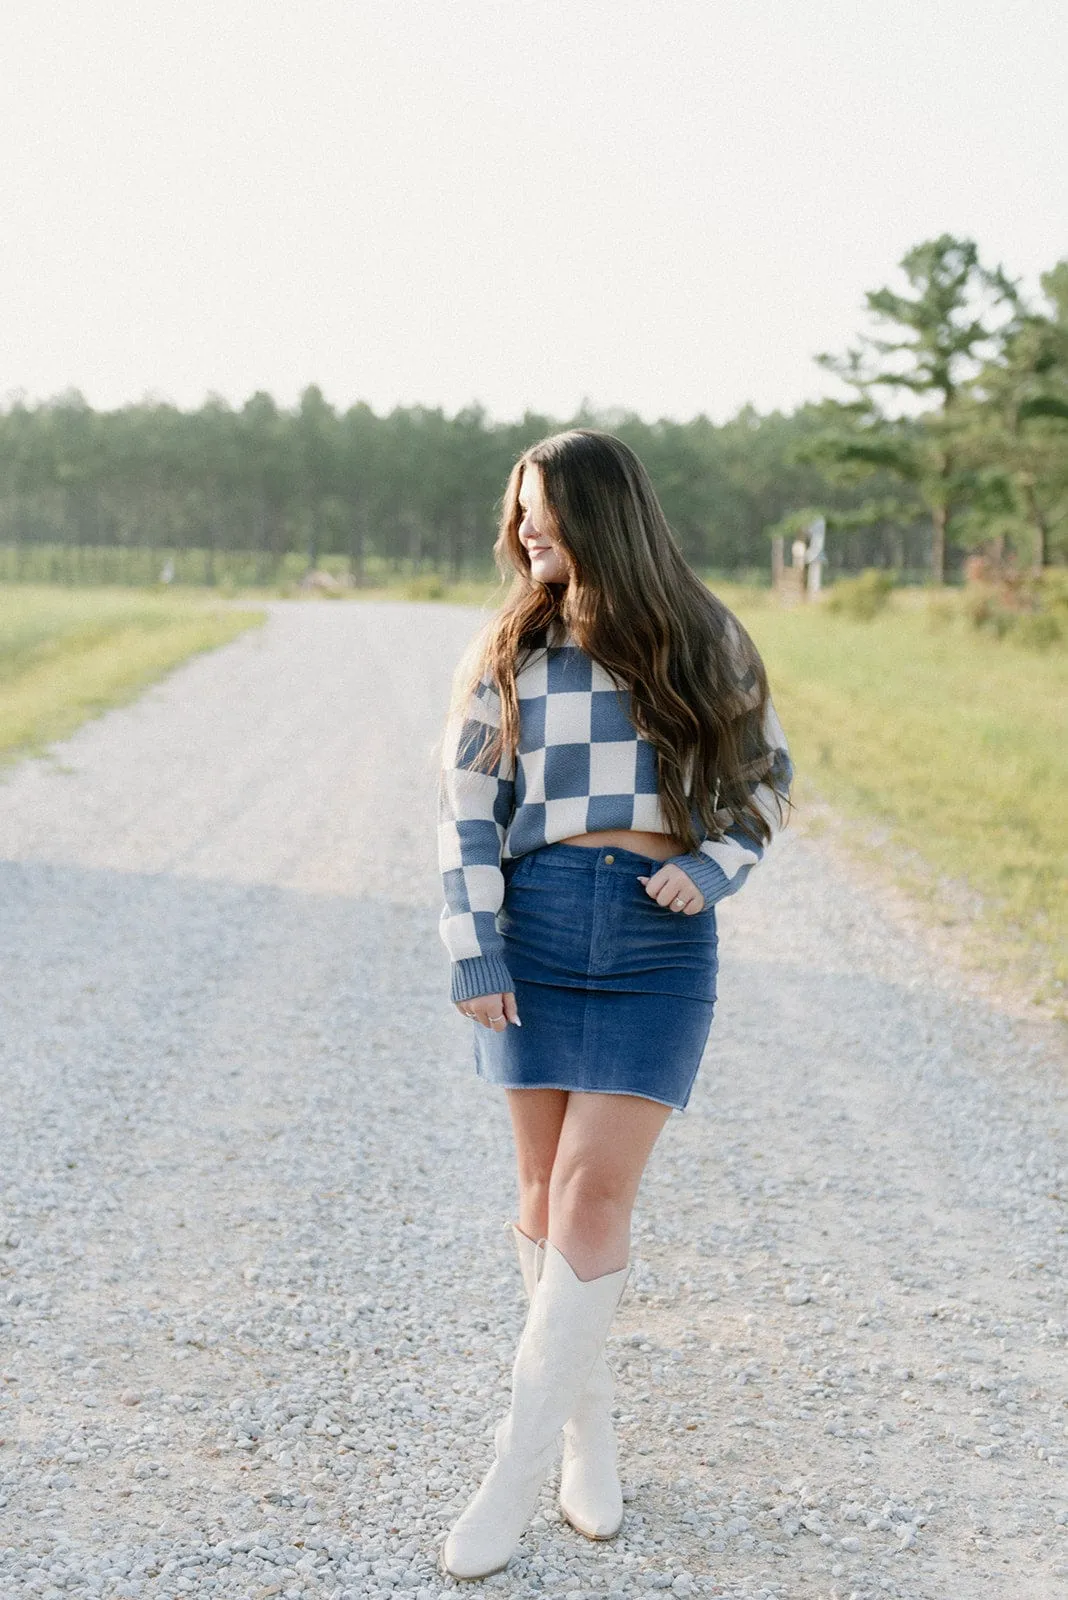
left=0, top=0, right=1068, bottom=421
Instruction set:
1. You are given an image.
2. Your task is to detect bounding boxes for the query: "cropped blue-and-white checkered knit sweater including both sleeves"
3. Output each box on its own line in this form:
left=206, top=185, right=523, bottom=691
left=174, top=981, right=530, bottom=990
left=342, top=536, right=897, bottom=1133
left=438, top=624, right=793, bottom=1000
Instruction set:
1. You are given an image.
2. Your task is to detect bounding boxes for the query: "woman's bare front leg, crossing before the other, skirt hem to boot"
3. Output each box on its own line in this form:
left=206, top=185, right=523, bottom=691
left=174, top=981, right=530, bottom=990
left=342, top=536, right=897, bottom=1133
left=546, top=1090, right=671, bottom=1280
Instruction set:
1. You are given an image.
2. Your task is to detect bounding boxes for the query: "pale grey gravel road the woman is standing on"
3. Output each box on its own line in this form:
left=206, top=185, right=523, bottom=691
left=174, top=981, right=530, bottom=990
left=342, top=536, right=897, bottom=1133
left=0, top=602, right=1068, bottom=1600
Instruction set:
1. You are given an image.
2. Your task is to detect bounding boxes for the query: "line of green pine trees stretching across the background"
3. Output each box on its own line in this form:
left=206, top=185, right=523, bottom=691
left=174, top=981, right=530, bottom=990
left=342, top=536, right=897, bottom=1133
left=0, top=235, right=1068, bottom=582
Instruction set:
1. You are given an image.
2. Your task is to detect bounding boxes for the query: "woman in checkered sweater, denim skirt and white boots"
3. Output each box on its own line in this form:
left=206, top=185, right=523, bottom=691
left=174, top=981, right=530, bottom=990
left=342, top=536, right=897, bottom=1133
left=438, top=429, right=791, bottom=1578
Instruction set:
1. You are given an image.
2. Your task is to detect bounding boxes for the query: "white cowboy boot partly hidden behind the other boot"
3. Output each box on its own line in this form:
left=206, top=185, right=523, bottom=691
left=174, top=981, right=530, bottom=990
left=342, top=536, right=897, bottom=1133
left=505, top=1222, right=624, bottom=1539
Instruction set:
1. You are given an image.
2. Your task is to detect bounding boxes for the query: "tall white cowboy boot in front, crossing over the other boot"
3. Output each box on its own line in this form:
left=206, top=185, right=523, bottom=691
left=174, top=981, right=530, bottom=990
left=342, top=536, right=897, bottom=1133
left=441, top=1238, right=630, bottom=1578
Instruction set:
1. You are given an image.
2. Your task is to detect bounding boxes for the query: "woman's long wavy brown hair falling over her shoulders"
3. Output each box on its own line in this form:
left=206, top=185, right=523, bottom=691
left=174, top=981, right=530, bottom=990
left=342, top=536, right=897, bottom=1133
left=457, top=427, right=783, bottom=850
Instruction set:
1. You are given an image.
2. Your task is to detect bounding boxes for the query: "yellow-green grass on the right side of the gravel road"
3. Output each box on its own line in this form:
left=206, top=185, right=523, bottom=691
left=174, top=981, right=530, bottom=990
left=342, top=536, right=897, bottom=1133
left=716, top=586, right=1068, bottom=1016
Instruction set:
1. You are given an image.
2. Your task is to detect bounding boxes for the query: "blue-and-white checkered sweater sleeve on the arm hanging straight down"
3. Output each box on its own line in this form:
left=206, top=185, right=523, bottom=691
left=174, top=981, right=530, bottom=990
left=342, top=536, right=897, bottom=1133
left=438, top=677, right=515, bottom=1000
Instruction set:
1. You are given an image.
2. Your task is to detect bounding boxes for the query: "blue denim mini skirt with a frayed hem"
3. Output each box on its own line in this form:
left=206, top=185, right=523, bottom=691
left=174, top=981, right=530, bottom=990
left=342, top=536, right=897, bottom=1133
left=475, top=843, right=719, bottom=1110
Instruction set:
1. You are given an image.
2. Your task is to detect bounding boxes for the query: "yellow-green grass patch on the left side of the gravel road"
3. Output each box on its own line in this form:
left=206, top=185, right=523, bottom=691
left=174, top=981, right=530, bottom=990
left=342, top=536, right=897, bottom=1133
left=0, top=584, right=265, bottom=766
